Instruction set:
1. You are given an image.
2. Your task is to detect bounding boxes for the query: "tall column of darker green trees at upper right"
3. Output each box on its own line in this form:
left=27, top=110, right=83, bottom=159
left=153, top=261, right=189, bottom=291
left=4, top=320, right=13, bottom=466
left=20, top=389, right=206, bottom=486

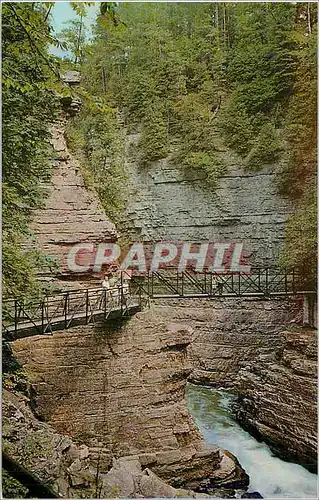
left=219, top=3, right=295, bottom=166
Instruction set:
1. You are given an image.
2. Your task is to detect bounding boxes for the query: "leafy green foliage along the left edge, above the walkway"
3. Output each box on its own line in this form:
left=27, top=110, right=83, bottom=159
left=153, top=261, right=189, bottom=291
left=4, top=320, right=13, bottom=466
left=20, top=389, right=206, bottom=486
left=2, top=3, right=58, bottom=297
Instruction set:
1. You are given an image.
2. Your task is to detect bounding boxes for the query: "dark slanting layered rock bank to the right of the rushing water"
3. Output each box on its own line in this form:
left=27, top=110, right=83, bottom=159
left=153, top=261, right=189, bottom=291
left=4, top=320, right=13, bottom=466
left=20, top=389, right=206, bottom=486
left=236, top=328, right=317, bottom=470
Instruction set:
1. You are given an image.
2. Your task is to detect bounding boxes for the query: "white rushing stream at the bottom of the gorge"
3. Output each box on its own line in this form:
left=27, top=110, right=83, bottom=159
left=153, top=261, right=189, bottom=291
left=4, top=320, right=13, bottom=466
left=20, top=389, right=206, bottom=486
left=186, top=384, right=317, bottom=499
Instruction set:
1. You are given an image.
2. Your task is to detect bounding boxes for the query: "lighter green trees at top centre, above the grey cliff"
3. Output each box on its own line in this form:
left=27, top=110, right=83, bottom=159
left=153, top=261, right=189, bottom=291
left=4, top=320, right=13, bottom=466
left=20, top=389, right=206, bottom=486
left=84, top=4, right=228, bottom=185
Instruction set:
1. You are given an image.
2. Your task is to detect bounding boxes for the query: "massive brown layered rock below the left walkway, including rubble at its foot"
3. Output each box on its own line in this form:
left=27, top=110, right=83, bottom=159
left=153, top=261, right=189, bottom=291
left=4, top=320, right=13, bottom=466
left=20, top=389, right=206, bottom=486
left=3, top=311, right=248, bottom=498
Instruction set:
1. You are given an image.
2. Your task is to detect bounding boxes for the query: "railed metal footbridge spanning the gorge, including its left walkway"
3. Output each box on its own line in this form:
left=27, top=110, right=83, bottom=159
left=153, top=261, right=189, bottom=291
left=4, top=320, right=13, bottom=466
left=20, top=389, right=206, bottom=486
left=2, top=268, right=316, bottom=340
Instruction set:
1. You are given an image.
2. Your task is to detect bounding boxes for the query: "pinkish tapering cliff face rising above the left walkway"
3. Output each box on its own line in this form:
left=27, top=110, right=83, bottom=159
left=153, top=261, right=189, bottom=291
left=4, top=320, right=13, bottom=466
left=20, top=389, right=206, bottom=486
left=30, top=118, right=117, bottom=287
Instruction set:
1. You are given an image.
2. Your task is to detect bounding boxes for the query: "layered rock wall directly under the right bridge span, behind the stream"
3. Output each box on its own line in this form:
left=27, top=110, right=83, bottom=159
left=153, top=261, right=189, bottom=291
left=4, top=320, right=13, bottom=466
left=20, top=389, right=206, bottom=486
left=150, top=299, right=299, bottom=388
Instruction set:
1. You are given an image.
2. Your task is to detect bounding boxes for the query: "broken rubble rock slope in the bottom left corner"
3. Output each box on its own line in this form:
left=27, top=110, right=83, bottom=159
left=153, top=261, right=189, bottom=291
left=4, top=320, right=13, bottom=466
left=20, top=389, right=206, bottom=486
left=2, top=390, right=221, bottom=498
